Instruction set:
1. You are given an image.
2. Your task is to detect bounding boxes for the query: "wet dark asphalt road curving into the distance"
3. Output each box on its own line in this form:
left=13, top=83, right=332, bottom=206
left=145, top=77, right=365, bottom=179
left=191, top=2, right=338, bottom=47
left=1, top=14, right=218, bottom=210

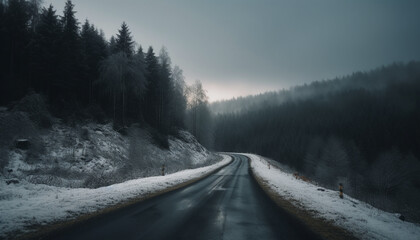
left=48, top=155, right=319, bottom=240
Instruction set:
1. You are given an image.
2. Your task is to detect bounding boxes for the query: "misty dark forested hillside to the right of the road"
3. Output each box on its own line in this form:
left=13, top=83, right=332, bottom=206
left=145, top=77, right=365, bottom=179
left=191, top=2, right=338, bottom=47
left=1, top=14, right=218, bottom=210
left=215, top=62, right=420, bottom=221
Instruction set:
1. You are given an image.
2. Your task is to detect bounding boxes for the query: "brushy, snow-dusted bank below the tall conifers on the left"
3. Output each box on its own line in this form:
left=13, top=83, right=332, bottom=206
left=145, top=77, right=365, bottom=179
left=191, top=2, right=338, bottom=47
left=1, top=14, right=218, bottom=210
left=0, top=108, right=220, bottom=188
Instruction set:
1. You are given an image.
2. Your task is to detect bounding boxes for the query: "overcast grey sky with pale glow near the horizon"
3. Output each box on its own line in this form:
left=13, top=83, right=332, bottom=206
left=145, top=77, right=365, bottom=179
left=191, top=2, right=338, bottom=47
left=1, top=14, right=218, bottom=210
left=44, top=0, right=420, bottom=101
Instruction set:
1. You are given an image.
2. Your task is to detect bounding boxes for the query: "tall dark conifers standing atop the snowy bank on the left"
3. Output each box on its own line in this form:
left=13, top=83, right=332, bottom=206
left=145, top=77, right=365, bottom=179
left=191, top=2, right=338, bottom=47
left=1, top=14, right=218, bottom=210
left=0, top=0, right=212, bottom=145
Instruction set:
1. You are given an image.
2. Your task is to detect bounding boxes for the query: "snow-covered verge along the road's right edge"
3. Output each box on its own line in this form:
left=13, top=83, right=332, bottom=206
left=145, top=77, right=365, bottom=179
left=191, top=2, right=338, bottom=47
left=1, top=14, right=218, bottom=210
left=244, top=154, right=420, bottom=240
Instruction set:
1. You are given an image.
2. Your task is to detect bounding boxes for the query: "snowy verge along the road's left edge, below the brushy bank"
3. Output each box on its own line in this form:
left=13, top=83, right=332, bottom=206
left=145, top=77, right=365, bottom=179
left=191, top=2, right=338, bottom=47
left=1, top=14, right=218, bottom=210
left=0, top=155, right=231, bottom=238
